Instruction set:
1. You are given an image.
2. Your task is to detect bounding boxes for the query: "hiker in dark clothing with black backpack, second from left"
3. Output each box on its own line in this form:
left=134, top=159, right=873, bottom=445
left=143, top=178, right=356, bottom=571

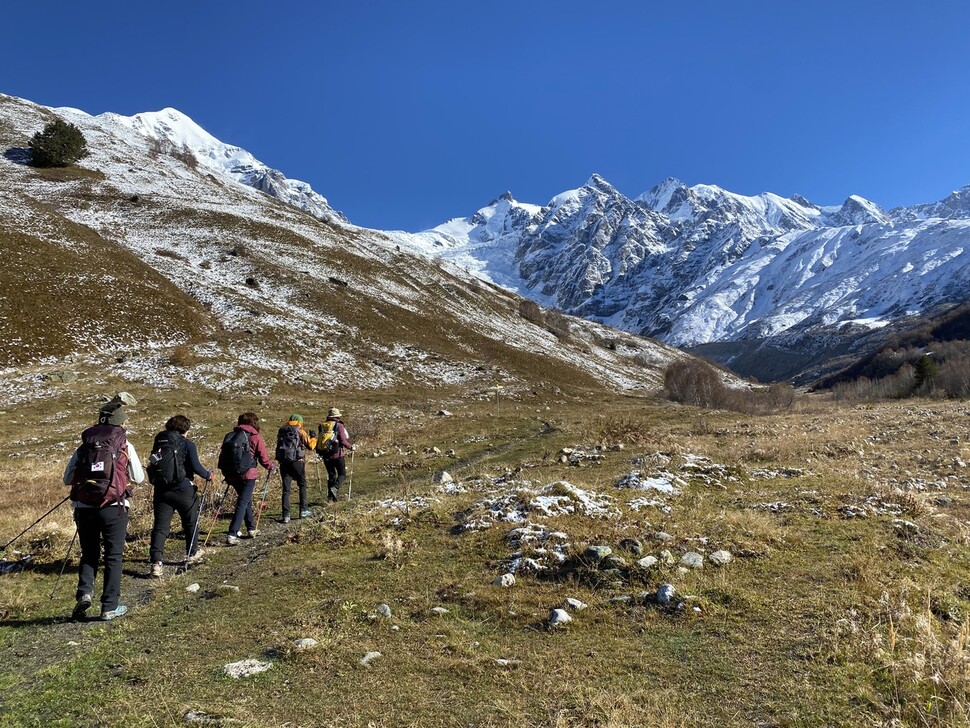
left=147, top=415, right=215, bottom=579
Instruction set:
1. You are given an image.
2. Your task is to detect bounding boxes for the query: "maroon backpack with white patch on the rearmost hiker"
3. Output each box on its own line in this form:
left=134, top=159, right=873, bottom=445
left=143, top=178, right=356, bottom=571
left=71, top=425, right=129, bottom=508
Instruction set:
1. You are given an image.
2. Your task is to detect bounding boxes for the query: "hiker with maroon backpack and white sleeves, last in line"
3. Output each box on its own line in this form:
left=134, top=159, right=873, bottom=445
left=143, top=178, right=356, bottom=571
left=64, top=397, right=145, bottom=620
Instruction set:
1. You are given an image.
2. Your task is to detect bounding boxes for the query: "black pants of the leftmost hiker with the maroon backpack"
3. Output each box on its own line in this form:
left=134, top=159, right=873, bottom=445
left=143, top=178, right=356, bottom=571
left=74, top=504, right=128, bottom=613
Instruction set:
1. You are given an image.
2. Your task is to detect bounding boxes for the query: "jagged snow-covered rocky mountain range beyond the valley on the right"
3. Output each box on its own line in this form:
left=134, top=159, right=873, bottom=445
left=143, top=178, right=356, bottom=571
left=405, top=175, right=970, bottom=378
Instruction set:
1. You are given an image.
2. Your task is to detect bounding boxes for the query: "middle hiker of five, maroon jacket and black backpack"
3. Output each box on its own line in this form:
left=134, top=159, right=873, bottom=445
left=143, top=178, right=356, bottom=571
left=219, top=412, right=276, bottom=546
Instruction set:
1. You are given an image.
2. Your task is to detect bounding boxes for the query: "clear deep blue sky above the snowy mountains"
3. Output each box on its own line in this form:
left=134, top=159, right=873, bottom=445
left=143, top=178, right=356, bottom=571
left=0, top=0, right=970, bottom=231
